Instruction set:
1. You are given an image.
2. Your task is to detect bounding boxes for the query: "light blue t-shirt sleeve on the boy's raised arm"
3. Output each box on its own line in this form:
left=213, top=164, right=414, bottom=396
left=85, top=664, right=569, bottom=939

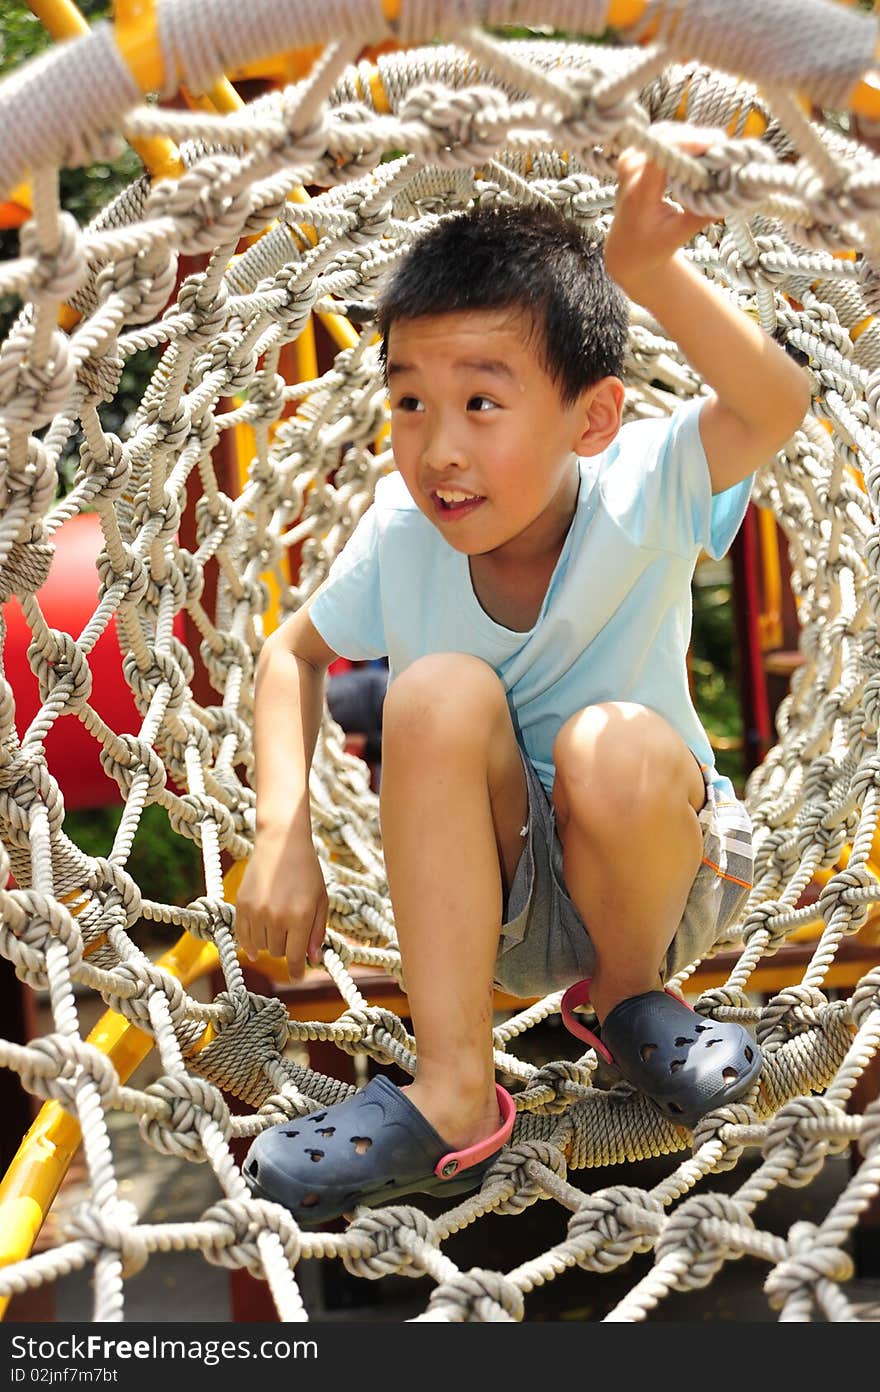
left=606, top=398, right=753, bottom=560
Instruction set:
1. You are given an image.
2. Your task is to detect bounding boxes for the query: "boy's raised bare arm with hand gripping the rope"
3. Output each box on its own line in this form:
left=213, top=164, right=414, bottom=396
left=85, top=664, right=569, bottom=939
left=606, top=125, right=810, bottom=493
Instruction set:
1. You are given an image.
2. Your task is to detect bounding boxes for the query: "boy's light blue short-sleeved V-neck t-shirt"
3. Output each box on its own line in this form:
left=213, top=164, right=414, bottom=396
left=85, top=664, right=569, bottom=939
left=311, top=401, right=752, bottom=796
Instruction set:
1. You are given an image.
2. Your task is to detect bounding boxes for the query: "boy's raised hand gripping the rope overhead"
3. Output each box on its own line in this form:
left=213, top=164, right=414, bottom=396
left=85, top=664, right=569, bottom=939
left=604, top=121, right=728, bottom=302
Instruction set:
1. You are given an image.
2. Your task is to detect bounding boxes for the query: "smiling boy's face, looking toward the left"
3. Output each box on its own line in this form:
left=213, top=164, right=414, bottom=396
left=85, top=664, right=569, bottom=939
left=387, top=309, right=595, bottom=560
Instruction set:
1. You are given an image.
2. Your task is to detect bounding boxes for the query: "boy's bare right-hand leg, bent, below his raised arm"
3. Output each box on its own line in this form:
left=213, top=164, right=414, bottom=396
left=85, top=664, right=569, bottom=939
left=553, top=703, right=705, bottom=1022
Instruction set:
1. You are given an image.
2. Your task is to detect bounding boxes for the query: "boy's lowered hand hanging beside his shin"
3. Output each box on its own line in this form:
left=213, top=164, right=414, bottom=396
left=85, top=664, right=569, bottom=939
left=235, top=828, right=329, bottom=981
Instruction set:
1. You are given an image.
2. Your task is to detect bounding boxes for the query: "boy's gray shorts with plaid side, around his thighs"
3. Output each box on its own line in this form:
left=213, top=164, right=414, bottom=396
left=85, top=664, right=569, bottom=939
left=496, top=754, right=753, bottom=997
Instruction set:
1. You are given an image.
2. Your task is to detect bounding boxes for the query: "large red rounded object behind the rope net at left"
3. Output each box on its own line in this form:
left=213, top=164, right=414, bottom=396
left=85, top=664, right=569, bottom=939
left=3, top=512, right=182, bottom=807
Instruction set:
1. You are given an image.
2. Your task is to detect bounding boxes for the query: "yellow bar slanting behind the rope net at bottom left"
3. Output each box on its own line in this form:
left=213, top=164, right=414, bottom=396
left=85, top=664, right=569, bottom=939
left=0, top=933, right=219, bottom=1317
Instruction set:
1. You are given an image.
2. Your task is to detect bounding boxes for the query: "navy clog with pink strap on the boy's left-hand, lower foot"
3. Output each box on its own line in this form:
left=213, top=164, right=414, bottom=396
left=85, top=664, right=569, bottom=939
left=244, top=1076, right=517, bottom=1226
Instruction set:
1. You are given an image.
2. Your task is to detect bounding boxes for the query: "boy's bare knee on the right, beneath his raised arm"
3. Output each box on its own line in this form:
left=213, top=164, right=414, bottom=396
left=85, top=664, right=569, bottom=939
left=553, top=702, right=690, bottom=830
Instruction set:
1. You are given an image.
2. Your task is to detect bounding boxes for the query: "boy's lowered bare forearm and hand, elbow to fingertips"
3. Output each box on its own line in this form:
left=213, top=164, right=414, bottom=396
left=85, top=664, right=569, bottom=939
left=235, top=603, right=337, bottom=980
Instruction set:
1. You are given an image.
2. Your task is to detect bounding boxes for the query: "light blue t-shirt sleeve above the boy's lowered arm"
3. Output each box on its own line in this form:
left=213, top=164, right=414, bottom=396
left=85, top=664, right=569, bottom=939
left=309, top=505, right=387, bottom=661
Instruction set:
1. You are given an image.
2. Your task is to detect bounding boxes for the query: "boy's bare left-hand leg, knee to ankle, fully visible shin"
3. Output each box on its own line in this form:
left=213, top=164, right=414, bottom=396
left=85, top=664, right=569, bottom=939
left=380, top=653, right=528, bottom=1146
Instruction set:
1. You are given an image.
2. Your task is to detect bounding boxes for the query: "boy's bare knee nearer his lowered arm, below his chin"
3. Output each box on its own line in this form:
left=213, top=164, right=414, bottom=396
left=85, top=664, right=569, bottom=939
left=383, top=653, right=507, bottom=749
